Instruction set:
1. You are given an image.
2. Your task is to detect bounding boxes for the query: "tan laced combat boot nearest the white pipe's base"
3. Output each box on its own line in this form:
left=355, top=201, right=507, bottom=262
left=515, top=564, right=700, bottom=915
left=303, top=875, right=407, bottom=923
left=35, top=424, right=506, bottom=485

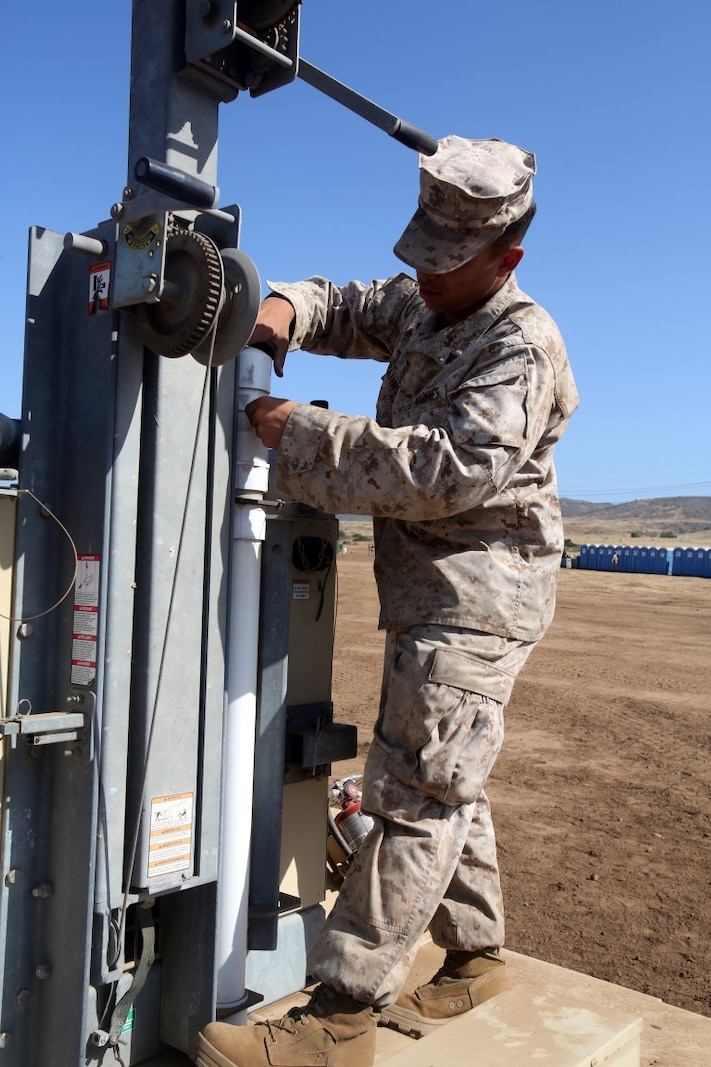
left=187, top=986, right=379, bottom=1067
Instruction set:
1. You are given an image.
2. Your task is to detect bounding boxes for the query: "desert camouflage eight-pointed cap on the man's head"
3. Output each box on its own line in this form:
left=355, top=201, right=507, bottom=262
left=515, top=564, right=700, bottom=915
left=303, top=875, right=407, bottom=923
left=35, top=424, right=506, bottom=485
left=394, top=134, right=536, bottom=274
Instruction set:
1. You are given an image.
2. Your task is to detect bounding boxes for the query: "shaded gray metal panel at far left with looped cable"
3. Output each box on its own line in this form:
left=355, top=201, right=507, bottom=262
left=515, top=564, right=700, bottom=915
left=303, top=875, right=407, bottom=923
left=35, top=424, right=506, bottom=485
left=2, top=225, right=122, bottom=1065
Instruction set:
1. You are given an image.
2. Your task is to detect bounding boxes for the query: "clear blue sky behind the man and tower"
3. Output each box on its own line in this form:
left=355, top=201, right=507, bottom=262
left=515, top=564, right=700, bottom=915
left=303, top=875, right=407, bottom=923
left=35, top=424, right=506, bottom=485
left=0, top=0, right=711, bottom=503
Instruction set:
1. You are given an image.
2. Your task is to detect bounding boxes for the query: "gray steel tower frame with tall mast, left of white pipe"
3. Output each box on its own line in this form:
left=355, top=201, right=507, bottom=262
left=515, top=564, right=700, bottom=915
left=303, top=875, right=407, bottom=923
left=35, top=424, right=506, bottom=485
left=0, top=0, right=249, bottom=1067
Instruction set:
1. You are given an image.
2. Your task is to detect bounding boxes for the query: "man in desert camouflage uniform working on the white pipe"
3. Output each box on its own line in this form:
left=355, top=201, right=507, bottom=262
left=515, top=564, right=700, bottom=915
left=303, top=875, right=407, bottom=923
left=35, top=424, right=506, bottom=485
left=195, top=137, right=578, bottom=1067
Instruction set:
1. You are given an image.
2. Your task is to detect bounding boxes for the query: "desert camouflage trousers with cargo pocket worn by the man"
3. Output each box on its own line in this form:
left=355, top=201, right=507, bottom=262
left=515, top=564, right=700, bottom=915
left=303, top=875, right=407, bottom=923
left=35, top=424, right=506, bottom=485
left=309, top=626, right=535, bottom=1007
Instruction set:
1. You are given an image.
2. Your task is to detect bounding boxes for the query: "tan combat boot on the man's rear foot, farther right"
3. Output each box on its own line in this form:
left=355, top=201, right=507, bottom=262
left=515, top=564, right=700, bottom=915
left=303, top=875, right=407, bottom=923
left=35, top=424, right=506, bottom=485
left=382, top=949, right=508, bottom=1037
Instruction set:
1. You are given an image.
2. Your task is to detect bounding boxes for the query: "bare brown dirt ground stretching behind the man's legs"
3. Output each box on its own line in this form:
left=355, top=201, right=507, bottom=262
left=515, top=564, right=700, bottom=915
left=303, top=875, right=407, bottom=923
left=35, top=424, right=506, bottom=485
left=333, top=545, right=711, bottom=1016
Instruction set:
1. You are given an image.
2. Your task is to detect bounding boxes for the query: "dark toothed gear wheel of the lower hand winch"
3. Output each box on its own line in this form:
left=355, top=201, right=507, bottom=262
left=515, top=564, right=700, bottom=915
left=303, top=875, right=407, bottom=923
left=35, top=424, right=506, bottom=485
left=132, top=229, right=225, bottom=357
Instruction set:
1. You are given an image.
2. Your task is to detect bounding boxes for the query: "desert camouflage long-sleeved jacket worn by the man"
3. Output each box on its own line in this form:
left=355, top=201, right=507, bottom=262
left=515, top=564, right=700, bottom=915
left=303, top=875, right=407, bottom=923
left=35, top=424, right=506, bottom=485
left=266, top=274, right=578, bottom=640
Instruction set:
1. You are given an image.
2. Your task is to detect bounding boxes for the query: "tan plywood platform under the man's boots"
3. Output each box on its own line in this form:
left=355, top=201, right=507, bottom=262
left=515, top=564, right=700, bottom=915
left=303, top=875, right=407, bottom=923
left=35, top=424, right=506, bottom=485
left=145, top=943, right=711, bottom=1067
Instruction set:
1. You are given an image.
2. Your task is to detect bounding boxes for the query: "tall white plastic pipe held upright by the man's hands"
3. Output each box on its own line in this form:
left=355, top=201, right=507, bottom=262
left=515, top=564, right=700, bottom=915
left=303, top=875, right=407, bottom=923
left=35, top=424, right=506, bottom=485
left=217, top=348, right=271, bottom=1022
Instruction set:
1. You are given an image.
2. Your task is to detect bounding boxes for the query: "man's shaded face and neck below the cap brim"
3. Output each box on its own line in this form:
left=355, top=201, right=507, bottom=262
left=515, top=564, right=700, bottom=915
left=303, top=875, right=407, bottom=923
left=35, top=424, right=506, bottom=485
left=409, top=246, right=523, bottom=327
